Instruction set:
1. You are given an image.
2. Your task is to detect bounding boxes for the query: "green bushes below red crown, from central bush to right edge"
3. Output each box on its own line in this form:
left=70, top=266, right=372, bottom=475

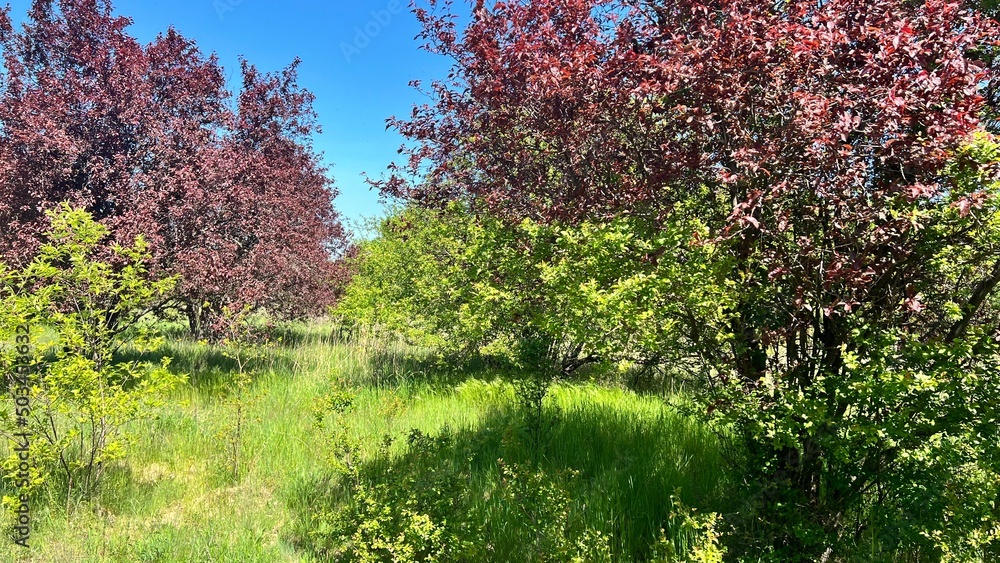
left=341, top=138, right=1000, bottom=561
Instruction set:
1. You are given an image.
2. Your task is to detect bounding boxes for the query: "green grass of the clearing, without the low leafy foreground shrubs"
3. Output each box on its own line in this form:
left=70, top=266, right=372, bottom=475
left=0, top=324, right=726, bottom=562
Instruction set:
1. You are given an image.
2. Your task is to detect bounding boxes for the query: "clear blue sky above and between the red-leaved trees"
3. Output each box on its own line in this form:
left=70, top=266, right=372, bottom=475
left=0, top=0, right=463, bottom=234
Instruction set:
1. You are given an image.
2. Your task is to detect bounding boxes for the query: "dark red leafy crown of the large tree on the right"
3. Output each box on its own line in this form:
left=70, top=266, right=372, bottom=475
left=376, top=0, right=993, bottom=226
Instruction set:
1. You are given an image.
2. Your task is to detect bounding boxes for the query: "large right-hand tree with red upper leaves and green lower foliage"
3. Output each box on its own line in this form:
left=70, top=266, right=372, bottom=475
left=376, top=0, right=1000, bottom=561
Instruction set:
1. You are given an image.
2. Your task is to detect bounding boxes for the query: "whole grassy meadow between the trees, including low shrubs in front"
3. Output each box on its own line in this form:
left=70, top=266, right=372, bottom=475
left=0, top=322, right=735, bottom=562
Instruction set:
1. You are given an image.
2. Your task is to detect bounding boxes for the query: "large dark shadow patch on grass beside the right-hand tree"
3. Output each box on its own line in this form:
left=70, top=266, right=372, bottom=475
left=289, top=396, right=730, bottom=562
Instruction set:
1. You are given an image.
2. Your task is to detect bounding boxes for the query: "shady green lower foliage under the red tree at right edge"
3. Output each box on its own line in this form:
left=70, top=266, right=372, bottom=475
left=715, top=136, right=1000, bottom=560
